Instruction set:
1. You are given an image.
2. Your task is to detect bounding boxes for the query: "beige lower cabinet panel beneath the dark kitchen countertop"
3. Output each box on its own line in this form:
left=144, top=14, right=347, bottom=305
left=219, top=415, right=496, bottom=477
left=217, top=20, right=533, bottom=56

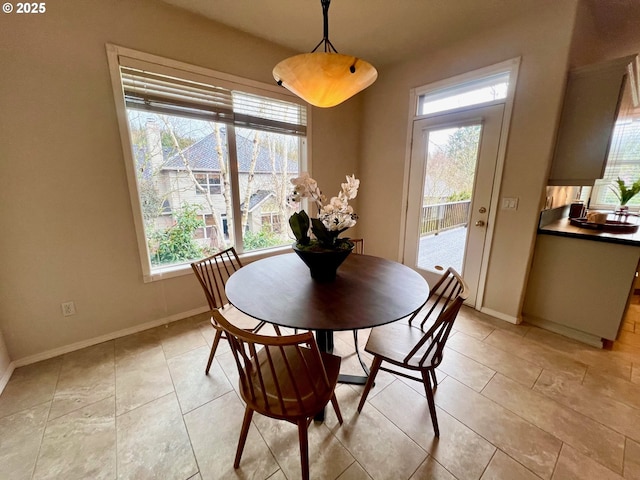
left=522, top=234, right=640, bottom=347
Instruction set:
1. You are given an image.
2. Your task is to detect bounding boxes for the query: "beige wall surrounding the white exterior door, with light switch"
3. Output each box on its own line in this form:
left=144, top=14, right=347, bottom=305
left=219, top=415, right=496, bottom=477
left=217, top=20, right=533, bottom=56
left=360, top=0, right=576, bottom=318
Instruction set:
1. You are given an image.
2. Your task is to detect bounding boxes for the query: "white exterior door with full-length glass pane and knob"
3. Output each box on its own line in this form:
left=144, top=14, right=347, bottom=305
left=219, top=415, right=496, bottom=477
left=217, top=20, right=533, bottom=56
left=404, top=104, right=504, bottom=307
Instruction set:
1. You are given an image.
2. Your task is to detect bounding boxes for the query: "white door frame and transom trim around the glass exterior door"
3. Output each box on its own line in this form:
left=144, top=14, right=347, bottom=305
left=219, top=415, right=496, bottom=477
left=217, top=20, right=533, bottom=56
left=398, top=57, right=520, bottom=310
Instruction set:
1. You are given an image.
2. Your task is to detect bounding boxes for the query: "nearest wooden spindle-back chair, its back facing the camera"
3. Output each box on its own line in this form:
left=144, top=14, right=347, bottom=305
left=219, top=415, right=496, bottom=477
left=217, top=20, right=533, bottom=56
left=213, top=310, right=342, bottom=480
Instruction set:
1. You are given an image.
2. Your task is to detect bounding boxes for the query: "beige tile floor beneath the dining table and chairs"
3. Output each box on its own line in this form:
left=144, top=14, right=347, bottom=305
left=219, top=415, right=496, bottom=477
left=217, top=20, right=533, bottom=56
left=0, top=302, right=640, bottom=480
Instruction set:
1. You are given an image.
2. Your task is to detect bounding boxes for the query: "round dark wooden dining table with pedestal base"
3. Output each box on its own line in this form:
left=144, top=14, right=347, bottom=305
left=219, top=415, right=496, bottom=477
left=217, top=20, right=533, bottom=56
left=225, top=253, right=429, bottom=368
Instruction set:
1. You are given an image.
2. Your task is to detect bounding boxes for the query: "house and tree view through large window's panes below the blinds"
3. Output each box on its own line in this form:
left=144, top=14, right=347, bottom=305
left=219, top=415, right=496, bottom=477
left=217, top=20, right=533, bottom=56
left=128, top=113, right=300, bottom=266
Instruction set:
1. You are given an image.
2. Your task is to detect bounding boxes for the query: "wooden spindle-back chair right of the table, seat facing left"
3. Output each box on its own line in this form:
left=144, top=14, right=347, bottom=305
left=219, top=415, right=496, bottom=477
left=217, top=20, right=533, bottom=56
left=358, top=268, right=468, bottom=437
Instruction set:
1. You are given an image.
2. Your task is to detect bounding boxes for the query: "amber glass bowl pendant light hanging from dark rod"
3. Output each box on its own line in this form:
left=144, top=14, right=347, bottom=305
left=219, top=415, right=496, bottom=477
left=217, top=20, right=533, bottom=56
left=273, top=0, right=378, bottom=107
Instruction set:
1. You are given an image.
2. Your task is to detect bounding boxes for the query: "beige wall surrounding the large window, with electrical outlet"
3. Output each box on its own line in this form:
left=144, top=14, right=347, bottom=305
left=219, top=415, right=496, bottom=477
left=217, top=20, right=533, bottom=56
left=0, top=0, right=359, bottom=361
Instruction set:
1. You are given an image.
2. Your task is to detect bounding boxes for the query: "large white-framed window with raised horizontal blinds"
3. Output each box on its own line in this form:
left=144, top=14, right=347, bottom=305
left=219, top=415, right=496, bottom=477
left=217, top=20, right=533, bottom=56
left=108, top=47, right=307, bottom=279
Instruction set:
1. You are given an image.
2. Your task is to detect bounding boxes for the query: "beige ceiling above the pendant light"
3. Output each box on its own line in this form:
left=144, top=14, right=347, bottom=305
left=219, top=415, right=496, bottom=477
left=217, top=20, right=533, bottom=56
left=162, top=0, right=564, bottom=66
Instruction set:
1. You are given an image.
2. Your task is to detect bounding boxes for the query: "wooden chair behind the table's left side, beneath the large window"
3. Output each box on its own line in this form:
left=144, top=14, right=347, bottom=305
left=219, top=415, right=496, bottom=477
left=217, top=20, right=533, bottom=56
left=191, top=247, right=280, bottom=374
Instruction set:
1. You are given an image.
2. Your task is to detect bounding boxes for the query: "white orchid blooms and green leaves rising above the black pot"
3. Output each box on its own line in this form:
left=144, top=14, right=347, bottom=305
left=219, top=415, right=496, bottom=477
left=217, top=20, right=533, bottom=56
left=289, top=172, right=360, bottom=250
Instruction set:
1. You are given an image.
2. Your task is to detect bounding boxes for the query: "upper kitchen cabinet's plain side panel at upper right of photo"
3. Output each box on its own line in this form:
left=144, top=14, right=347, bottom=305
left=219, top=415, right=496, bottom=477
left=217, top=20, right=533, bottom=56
left=548, top=57, right=634, bottom=185
